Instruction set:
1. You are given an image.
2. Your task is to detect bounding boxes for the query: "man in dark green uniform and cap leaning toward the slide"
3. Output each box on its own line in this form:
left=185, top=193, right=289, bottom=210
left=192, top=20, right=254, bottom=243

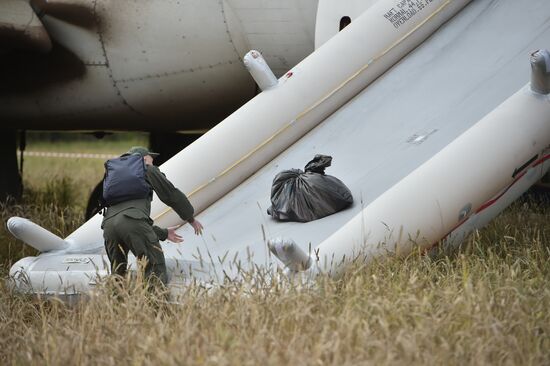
left=101, top=146, right=203, bottom=284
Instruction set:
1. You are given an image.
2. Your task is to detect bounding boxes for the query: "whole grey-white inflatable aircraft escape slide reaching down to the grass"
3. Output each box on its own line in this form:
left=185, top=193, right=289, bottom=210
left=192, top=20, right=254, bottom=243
left=8, top=0, right=550, bottom=292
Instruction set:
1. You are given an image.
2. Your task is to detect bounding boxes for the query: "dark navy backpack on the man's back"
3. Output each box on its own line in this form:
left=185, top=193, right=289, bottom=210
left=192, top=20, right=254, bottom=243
left=100, top=154, right=153, bottom=207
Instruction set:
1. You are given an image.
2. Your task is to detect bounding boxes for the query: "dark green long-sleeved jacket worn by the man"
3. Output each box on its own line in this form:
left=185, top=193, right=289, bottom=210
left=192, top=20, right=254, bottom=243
left=101, top=165, right=194, bottom=240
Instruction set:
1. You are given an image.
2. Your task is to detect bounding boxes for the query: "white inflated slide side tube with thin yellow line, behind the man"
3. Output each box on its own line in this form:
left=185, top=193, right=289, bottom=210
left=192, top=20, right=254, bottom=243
left=66, top=0, right=478, bottom=246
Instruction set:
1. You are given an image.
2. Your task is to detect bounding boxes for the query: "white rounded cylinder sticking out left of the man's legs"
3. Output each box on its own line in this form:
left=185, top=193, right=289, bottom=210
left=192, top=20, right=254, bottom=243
left=8, top=217, right=69, bottom=252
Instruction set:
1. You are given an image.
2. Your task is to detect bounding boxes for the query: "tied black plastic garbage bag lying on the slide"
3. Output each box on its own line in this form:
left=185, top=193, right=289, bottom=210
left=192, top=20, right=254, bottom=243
left=267, top=155, right=353, bottom=222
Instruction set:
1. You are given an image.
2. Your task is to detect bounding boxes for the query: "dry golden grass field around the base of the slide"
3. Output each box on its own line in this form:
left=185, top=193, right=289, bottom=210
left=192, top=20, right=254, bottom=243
left=0, top=135, right=550, bottom=365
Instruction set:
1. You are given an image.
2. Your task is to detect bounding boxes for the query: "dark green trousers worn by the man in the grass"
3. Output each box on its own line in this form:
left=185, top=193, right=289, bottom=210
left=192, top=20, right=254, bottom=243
left=103, top=212, right=168, bottom=284
